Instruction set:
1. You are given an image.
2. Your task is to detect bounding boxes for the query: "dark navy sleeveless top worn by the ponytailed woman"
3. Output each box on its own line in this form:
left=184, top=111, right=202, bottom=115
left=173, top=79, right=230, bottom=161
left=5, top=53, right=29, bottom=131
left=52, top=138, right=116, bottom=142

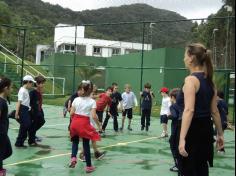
left=176, top=72, right=214, bottom=119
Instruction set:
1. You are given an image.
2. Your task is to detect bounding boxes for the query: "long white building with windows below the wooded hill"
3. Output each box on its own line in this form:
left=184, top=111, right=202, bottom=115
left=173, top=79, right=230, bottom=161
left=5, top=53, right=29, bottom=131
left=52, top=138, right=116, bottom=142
left=36, top=24, right=152, bottom=64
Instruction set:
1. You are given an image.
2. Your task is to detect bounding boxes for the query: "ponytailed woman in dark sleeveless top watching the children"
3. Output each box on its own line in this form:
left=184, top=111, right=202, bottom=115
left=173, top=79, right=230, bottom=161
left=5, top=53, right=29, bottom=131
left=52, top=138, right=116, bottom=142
left=177, top=44, right=224, bottom=176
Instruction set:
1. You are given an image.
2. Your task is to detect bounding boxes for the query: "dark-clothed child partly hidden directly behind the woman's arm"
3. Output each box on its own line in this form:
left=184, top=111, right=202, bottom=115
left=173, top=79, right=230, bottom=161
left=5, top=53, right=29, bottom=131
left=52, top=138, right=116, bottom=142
left=168, top=89, right=179, bottom=172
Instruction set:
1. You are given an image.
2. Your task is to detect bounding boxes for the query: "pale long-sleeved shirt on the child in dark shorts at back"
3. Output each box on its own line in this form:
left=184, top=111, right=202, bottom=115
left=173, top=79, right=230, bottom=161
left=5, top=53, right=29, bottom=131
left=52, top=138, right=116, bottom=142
left=121, top=92, right=137, bottom=109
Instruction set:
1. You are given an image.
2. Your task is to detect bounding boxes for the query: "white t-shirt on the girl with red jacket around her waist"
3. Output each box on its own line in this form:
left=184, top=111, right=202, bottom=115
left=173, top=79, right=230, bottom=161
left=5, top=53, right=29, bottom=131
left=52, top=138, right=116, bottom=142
left=72, top=97, right=97, bottom=117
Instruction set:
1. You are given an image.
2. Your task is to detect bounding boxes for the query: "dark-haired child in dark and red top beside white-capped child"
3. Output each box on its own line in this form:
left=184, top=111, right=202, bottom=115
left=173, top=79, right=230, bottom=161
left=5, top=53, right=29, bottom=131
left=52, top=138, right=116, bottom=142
left=28, top=76, right=46, bottom=146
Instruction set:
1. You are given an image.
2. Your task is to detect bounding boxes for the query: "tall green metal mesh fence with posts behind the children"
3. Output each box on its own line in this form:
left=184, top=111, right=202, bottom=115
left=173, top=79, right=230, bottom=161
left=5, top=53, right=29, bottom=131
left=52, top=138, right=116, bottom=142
left=0, top=16, right=235, bottom=123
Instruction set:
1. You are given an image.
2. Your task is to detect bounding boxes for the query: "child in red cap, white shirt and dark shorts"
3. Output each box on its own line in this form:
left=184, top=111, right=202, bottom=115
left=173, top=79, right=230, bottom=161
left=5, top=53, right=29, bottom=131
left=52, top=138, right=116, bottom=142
left=160, top=87, right=171, bottom=138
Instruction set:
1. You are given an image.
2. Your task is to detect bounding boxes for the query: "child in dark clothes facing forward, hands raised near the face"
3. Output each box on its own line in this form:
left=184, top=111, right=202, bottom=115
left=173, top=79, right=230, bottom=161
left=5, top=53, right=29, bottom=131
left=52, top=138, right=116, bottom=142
left=140, top=83, right=154, bottom=132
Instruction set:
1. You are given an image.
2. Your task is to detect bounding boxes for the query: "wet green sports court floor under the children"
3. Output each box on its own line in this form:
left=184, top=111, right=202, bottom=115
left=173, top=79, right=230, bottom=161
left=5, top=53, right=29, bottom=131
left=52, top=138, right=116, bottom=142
left=4, top=104, right=235, bottom=176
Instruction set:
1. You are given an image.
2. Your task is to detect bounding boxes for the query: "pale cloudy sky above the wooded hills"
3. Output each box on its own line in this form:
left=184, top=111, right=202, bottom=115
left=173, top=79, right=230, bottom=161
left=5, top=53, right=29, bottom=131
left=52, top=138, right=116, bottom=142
left=42, top=0, right=223, bottom=19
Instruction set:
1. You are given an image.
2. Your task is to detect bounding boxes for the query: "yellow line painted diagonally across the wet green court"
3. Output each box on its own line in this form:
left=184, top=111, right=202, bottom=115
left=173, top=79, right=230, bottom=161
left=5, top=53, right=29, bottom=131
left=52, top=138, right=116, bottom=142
left=4, top=137, right=161, bottom=167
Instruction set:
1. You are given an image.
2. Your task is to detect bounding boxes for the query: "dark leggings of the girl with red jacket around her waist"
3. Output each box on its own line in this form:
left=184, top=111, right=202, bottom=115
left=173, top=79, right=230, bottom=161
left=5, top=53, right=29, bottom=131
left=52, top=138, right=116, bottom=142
left=71, top=138, right=92, bottom=167
